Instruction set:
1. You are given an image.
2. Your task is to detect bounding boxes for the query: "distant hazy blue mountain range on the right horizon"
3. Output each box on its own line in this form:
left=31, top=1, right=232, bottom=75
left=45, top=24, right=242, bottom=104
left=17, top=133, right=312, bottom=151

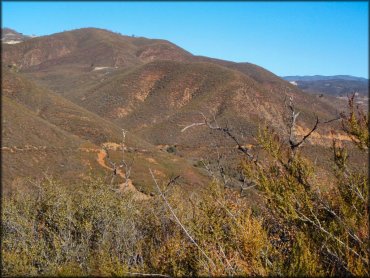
left=283, top=75, right=369, bottom=98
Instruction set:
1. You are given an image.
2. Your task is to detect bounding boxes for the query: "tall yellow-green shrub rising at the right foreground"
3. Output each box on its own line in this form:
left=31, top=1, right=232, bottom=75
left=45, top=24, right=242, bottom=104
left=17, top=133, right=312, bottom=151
left=243, top=98, right=370, bottom=276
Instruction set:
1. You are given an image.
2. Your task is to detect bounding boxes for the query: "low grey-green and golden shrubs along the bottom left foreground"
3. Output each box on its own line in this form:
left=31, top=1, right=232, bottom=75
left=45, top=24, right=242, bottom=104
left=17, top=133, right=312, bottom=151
left=2, top=174, right=268, bottom=276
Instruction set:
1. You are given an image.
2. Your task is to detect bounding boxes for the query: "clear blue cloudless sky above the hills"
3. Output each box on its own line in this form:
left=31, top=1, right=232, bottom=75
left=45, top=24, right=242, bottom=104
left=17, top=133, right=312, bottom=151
left=2, top=1, right=369, bottom=78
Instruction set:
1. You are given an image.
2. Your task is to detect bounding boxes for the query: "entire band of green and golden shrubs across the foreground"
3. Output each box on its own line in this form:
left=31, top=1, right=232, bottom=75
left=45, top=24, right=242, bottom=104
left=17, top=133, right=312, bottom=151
left=2, top=98, right=370, bottom=276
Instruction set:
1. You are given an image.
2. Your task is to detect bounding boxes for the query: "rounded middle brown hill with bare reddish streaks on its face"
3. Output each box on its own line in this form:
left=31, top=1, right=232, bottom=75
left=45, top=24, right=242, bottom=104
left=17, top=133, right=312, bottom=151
left=71, top=61, right=342, bottom=146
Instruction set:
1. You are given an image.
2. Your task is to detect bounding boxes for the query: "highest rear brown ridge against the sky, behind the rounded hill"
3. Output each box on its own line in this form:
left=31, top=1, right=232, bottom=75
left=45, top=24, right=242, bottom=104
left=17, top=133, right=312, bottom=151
left=3, top=28, right=190, bottom=70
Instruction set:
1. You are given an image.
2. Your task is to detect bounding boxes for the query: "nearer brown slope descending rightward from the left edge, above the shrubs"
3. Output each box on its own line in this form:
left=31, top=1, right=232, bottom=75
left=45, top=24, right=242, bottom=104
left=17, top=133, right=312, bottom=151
left=2, top=69, right=210, bottom=193
